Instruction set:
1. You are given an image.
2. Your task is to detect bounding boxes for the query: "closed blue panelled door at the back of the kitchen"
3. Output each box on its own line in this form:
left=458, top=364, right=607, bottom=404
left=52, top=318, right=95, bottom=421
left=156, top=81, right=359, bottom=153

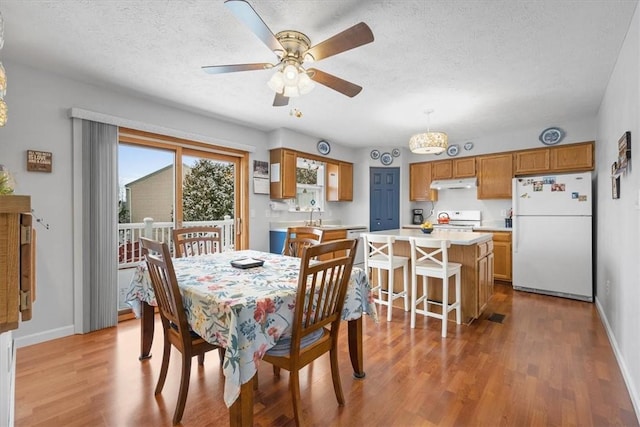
left=369, top=168, right=400, bottom=231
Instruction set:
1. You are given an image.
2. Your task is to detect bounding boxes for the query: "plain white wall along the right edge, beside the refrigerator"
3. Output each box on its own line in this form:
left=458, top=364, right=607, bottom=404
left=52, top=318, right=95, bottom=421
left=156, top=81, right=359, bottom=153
left=596, top=3, right=640, bottom=414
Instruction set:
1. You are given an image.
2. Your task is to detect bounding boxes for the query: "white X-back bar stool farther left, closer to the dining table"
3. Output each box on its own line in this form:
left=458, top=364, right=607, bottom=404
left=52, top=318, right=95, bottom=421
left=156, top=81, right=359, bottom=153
left=362, top=233, right=409, bottom=321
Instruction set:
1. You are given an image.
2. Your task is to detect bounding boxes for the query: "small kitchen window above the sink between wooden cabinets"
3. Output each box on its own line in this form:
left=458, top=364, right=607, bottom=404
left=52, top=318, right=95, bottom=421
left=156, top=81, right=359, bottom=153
left=289, top=157, right=325, bottom=212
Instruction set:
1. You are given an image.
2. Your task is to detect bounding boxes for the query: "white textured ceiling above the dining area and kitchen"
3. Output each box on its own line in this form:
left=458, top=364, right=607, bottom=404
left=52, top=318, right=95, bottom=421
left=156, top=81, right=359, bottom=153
left=0, top=0, right=637, bottom=147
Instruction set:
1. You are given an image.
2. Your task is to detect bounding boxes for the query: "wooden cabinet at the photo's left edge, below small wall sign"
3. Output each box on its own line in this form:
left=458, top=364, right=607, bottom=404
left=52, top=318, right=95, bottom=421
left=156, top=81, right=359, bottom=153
left=0, top=196, right=35, bottom=333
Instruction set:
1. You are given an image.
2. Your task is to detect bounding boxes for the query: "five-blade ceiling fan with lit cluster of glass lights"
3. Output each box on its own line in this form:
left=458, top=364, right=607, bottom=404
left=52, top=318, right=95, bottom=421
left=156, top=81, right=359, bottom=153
left=202, top=0, right=373, bottom=107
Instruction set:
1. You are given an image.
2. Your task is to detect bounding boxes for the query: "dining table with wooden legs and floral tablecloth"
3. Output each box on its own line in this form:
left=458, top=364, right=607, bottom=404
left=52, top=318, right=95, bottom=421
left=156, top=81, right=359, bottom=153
left=125, top=250, right=378, bottom=426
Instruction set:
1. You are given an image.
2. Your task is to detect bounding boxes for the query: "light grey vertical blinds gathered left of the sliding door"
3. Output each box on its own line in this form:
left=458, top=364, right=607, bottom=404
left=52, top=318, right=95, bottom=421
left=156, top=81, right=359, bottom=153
left=82, top=120, right=118, bottom=333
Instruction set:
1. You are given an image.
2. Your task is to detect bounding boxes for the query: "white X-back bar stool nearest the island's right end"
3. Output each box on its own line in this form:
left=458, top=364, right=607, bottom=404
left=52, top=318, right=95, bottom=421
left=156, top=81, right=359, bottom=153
left=409, top=237, right=462, bottom=338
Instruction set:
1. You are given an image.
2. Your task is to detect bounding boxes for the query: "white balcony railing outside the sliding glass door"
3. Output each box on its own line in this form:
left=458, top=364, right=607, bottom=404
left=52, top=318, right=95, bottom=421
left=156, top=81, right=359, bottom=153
left=118, top=216, right=235, bottom=268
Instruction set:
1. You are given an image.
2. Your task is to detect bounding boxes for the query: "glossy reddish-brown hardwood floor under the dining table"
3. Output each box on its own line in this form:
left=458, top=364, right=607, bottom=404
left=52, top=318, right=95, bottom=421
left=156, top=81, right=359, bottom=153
left=16, top=285, right=638, bottom=427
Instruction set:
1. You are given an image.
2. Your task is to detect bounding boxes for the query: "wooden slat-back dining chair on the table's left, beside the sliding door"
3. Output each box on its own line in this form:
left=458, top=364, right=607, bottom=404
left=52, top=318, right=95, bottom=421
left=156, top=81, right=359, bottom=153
left=140, top=237, right=223, bottom=425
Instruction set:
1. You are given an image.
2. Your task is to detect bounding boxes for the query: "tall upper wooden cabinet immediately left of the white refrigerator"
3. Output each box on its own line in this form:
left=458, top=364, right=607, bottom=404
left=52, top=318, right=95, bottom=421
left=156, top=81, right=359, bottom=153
left=477, top=153, right=513, bottom=199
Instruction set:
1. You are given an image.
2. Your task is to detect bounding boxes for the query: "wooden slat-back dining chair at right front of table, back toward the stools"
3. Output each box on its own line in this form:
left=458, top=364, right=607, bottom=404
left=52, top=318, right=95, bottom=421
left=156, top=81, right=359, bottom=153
left=263, top=239, right=358, bottom=425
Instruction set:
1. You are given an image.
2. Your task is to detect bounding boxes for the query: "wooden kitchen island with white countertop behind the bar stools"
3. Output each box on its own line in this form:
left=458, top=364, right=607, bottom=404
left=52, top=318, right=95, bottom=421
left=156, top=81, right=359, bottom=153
left=364, top=229, right=493, bottom=323
